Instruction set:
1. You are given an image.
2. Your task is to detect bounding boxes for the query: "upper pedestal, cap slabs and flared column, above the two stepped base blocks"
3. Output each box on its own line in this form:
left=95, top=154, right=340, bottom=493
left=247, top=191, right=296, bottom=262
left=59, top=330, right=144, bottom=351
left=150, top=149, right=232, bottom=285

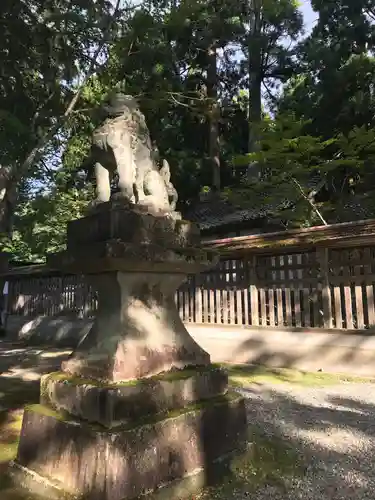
left=50, top=202, right=215, bottom=382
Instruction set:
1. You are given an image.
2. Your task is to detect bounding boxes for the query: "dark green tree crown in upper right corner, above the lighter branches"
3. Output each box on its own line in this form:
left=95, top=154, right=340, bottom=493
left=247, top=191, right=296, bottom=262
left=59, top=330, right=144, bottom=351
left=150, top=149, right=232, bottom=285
left=280, top=0, right=375, bottom=135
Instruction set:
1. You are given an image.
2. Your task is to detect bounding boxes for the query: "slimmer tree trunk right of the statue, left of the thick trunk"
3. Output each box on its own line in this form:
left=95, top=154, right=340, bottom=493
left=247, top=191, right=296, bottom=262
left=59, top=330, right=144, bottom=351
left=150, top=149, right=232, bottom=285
left=207, top=47, right=221, bottom=193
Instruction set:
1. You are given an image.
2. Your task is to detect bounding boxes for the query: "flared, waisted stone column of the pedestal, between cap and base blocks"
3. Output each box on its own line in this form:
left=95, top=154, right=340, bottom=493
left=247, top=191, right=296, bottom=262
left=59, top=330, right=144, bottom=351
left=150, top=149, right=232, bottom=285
left=59, top=270, right=210, bottom=382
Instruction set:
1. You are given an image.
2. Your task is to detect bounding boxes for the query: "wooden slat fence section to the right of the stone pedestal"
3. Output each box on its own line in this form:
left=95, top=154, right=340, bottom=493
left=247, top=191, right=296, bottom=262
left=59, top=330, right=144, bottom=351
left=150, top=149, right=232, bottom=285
left=177, top=247, right=375, bottom=330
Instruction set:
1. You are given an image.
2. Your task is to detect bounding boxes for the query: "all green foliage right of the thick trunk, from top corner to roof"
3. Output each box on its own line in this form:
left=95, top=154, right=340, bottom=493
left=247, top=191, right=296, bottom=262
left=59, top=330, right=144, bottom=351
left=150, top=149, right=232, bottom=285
left=229, top=0, right=375, bottom=226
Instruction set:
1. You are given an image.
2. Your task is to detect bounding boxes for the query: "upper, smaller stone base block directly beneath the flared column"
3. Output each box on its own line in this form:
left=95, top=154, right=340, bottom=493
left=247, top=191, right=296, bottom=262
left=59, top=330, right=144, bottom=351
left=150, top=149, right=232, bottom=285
left=40, top=366, right=228, bottom=428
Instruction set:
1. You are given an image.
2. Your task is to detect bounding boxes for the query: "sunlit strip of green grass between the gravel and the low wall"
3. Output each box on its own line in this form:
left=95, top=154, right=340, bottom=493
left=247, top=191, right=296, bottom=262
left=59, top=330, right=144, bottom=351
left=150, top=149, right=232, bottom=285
left=225, top=365, right=375, bottom=388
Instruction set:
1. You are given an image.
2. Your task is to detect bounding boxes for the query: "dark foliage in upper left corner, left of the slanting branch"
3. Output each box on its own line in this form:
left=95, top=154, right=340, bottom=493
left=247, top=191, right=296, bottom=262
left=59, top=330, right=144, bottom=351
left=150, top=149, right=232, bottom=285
left=0, top=0, right=115, bottom=164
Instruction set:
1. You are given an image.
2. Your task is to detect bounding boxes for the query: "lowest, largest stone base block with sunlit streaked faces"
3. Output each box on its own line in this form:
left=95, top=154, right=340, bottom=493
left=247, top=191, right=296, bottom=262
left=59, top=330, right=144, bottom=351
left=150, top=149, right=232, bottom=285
left=16, top=393, right=247, bottom=500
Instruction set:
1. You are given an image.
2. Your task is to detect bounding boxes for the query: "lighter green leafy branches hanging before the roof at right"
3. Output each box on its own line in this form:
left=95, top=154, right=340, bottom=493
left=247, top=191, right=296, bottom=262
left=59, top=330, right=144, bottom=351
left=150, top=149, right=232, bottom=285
left=226, top=115, right=375, bottom=226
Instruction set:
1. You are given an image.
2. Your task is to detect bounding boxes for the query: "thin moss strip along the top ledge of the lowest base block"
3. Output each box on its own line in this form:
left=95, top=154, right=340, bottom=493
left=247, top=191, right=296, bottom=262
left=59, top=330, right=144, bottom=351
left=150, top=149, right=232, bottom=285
left=25, top=391, right=242, bottom=433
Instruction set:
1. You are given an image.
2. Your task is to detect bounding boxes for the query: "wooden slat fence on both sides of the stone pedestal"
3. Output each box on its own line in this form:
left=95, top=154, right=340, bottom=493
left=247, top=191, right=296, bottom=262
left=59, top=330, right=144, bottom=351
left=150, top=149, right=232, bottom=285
left=8, top=246, right=375, bottom=330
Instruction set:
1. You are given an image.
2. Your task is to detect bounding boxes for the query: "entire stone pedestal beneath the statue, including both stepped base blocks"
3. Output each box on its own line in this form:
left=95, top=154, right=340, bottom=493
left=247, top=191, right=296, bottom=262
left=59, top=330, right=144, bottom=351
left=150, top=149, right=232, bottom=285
left=16, top=202, right=246, bottom=500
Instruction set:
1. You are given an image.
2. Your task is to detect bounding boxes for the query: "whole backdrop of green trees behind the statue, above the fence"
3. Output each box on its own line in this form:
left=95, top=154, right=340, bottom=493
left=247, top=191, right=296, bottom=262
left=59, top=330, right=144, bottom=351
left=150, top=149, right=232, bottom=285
left=0, top=0, right=375, bottom=261
